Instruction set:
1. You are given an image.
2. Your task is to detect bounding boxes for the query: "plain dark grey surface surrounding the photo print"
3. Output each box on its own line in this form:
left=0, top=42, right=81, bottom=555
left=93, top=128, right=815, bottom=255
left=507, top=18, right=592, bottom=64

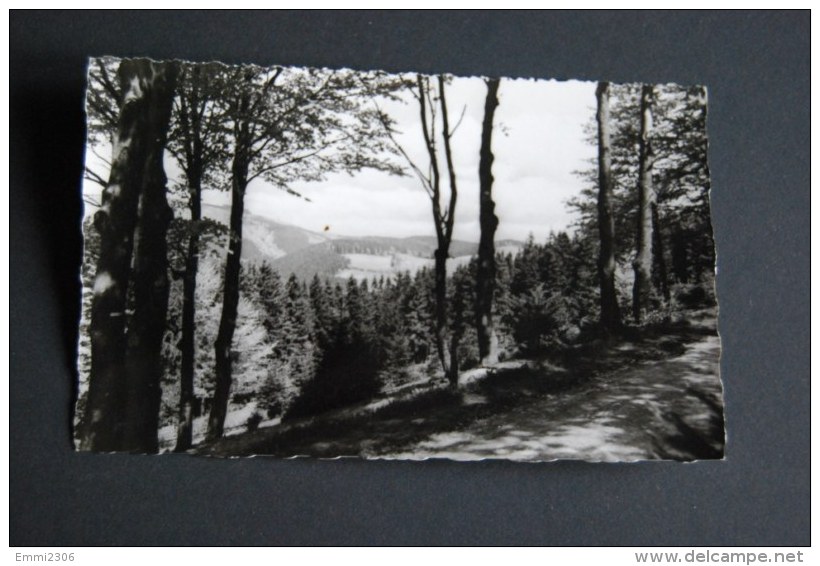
left=9, top=11, right=810, bottom=545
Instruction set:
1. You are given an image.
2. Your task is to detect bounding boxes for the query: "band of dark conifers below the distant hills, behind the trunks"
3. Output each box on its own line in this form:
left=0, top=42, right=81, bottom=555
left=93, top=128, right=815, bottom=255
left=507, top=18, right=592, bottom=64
left=80, top=226, right=597, bottom=441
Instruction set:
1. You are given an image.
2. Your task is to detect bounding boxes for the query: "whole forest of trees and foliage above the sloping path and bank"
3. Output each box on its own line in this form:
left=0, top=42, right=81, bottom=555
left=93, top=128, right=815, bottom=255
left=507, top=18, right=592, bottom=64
left=75, top=59, right=714, bottom=458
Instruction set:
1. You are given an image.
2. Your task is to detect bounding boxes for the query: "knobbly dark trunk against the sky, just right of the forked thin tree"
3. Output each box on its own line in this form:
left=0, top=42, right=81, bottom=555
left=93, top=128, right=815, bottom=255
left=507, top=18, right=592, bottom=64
left=475, top=79, right=499, bottom=365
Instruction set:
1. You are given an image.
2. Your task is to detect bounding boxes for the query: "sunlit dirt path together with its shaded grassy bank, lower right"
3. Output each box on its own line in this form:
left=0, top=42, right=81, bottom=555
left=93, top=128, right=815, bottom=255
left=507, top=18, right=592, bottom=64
left=202, top=333, right=723, bottom=461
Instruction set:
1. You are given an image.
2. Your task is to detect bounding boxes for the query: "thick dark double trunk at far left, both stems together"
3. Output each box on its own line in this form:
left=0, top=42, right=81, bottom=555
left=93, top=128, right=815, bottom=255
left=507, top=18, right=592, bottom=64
left=80, top=59, right=176, bottom=452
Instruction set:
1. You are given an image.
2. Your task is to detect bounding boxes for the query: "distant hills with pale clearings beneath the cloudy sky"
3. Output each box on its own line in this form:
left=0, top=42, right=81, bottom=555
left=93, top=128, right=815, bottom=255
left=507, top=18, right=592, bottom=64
left=202, top=205, right=523, bottom=280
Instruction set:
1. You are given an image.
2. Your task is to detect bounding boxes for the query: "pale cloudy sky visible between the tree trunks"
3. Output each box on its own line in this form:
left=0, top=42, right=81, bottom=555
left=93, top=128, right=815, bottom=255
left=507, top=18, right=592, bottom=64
left=86, top=70, right=596, bottom=241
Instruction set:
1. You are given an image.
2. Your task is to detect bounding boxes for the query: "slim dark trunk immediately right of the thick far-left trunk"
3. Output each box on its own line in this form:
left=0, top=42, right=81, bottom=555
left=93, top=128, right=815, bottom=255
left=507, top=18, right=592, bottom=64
left=174, top=171, right=202, bottom=452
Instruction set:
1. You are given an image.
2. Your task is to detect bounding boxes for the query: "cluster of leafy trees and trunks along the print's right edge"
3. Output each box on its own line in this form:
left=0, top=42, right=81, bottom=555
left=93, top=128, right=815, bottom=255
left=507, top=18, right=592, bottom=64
left=569, top=83, right=715, bottom=328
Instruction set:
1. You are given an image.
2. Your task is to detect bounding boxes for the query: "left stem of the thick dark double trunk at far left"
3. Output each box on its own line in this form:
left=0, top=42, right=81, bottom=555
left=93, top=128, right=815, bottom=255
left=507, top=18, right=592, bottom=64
left=81, top=59, right=176, bottom=451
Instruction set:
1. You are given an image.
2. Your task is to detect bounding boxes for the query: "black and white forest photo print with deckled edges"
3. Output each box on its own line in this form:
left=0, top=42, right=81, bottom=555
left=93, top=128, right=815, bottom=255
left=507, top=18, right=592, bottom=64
left=73, top=57, right=725, bottom=462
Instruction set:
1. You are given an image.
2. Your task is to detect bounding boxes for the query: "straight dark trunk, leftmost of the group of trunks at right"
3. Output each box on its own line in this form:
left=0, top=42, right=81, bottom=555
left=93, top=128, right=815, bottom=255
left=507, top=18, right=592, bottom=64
left=595, top=82, right=621, bottom=332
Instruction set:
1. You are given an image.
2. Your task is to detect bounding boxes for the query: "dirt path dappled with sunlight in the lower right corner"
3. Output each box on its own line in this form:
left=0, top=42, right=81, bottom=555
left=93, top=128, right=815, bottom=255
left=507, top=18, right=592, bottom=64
left=374, top=336, right=722, bottom=461
